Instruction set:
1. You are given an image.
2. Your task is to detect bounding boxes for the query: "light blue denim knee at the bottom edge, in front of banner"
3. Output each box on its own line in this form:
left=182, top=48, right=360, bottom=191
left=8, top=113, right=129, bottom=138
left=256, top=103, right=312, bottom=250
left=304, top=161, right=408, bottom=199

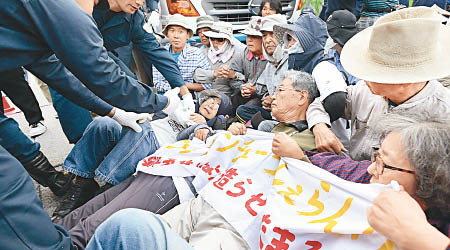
left=86, top=208, right=193, bottom=250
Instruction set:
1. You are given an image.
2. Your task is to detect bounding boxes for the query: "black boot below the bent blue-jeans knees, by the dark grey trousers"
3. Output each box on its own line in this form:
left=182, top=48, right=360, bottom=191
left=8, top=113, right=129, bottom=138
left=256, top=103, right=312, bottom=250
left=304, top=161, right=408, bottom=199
left=52, top=176, right=100, bottom=221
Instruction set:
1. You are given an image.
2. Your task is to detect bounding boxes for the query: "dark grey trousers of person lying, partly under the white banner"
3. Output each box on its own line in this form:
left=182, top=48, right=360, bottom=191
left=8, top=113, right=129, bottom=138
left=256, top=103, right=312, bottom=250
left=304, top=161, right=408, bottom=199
left=58, top=173, right=180, bottom=249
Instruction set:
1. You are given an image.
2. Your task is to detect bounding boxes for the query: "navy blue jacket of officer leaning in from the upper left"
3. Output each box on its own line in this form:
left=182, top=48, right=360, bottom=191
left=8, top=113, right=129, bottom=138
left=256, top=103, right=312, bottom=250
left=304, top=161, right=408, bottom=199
left=0, top=0, right=167, bottom=115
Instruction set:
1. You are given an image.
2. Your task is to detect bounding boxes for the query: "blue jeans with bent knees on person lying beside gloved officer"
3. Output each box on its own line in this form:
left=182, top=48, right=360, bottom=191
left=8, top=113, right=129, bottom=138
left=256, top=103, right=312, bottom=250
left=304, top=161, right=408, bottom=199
left=62, top=117, right=159, bottom=185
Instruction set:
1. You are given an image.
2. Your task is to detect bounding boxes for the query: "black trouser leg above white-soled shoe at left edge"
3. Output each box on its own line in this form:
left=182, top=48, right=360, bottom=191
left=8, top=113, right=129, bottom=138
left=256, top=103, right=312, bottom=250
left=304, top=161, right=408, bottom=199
left=0, top=68, right=44, bottom=124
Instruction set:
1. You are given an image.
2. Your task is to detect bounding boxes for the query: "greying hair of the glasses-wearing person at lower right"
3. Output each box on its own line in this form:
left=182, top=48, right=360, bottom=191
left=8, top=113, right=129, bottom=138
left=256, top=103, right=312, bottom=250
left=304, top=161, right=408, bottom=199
left=377, top=110, right=450, bottom=218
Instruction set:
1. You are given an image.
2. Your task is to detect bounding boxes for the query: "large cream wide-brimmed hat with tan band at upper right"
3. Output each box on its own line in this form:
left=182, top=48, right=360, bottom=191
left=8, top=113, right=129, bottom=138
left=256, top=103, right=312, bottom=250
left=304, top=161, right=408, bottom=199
left=341, top=7, right=450, bottom=84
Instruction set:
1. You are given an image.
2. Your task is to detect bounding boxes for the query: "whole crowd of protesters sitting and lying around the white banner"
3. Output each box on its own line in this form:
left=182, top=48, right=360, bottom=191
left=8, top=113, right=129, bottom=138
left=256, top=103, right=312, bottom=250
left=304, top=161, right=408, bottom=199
left=0, top=0, right=450, bottom=250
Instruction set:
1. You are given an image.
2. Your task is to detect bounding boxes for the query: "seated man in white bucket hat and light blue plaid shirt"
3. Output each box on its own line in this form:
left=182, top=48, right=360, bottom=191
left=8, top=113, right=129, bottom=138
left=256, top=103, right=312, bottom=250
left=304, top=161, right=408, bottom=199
left=153, top=14, right=211, bottom=93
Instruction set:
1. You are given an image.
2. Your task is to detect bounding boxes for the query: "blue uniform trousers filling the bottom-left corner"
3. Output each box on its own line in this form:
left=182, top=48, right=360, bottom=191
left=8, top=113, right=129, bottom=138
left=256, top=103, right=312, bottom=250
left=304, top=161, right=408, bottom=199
left=0, top=146, right=75, bottom=250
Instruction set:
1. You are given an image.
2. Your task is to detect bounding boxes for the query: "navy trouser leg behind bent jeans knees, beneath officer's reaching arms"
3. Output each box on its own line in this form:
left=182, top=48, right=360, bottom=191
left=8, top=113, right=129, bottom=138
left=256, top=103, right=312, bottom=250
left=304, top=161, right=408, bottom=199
left=48, top=87, right=92, bottom=143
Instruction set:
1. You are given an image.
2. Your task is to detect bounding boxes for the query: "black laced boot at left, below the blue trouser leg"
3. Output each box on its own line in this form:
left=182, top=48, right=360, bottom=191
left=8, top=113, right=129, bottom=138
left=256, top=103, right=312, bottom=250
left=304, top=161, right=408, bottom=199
left=22, top=152, right=73, bottom=196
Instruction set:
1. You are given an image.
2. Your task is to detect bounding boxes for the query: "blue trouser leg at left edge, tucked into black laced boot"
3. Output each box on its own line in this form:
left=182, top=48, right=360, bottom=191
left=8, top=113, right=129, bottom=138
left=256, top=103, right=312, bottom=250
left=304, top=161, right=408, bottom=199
left=0, top=112, right=41, bottom=163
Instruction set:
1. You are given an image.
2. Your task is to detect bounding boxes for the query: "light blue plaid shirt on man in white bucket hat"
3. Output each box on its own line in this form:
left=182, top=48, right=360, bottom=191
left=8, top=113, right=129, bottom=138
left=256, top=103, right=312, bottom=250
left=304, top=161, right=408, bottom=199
left=152, top=44, right=211, bottom=92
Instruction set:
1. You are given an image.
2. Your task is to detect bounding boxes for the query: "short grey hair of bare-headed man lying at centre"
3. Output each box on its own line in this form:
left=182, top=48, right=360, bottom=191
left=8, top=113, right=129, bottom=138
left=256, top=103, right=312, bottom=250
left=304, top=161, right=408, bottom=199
left=283, top=70, right=319, bottom=103
